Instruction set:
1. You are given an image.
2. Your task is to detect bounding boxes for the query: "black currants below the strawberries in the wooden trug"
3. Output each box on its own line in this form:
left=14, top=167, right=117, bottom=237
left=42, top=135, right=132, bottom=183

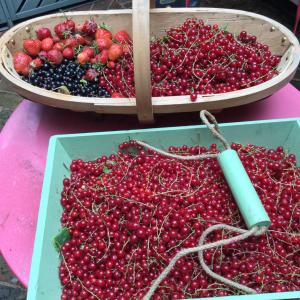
left=24, top=59, right=110, bottom=98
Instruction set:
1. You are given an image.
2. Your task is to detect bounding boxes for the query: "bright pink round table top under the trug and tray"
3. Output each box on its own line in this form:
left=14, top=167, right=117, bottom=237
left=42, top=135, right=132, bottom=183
left=0, top=84, right=300, bottom=286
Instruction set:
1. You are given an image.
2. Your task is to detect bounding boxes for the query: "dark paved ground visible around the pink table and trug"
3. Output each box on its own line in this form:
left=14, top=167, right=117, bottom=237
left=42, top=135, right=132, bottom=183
left=0, top=0, right=300, bottom=300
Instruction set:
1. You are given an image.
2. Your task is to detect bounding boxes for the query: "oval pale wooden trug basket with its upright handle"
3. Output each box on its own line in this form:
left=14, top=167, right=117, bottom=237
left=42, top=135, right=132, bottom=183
left=0, top=0, right=300, bottom=123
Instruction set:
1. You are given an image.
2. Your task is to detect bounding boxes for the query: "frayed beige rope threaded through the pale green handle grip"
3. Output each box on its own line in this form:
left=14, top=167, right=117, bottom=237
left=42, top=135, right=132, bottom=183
left=136, top=110, right=267, bottom=300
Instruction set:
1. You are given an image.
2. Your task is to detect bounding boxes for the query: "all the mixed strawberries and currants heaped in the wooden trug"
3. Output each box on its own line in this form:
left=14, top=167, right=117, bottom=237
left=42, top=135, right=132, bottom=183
left=13, top=19, right=280, bottom=101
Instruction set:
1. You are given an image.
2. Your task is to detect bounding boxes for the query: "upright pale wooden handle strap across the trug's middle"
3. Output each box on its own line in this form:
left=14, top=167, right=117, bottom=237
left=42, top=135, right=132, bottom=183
left=132, top=0, right=154, bottom=123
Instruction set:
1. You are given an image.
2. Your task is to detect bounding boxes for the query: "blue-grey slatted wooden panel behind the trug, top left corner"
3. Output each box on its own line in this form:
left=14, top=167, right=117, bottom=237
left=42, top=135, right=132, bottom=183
left=3, top=0, right=86, bottom=21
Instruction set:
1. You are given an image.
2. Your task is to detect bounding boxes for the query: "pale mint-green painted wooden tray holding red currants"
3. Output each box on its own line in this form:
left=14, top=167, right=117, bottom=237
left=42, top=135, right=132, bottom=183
left=27, top=119, right=300, bottom=300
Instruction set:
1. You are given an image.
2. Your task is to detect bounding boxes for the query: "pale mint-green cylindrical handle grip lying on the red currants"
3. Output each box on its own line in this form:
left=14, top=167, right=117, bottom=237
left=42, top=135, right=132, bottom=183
left=218, top=149, right=271, bottom=229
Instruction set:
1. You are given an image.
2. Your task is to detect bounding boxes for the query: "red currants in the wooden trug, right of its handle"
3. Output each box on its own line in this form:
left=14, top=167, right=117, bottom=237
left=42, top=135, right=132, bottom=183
left=151, top=19, right=280, bottom=100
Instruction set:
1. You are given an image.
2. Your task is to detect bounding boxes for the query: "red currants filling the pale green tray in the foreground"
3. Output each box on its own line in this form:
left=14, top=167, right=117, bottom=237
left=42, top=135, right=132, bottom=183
left=59, top=141, right=300, bottom=300
